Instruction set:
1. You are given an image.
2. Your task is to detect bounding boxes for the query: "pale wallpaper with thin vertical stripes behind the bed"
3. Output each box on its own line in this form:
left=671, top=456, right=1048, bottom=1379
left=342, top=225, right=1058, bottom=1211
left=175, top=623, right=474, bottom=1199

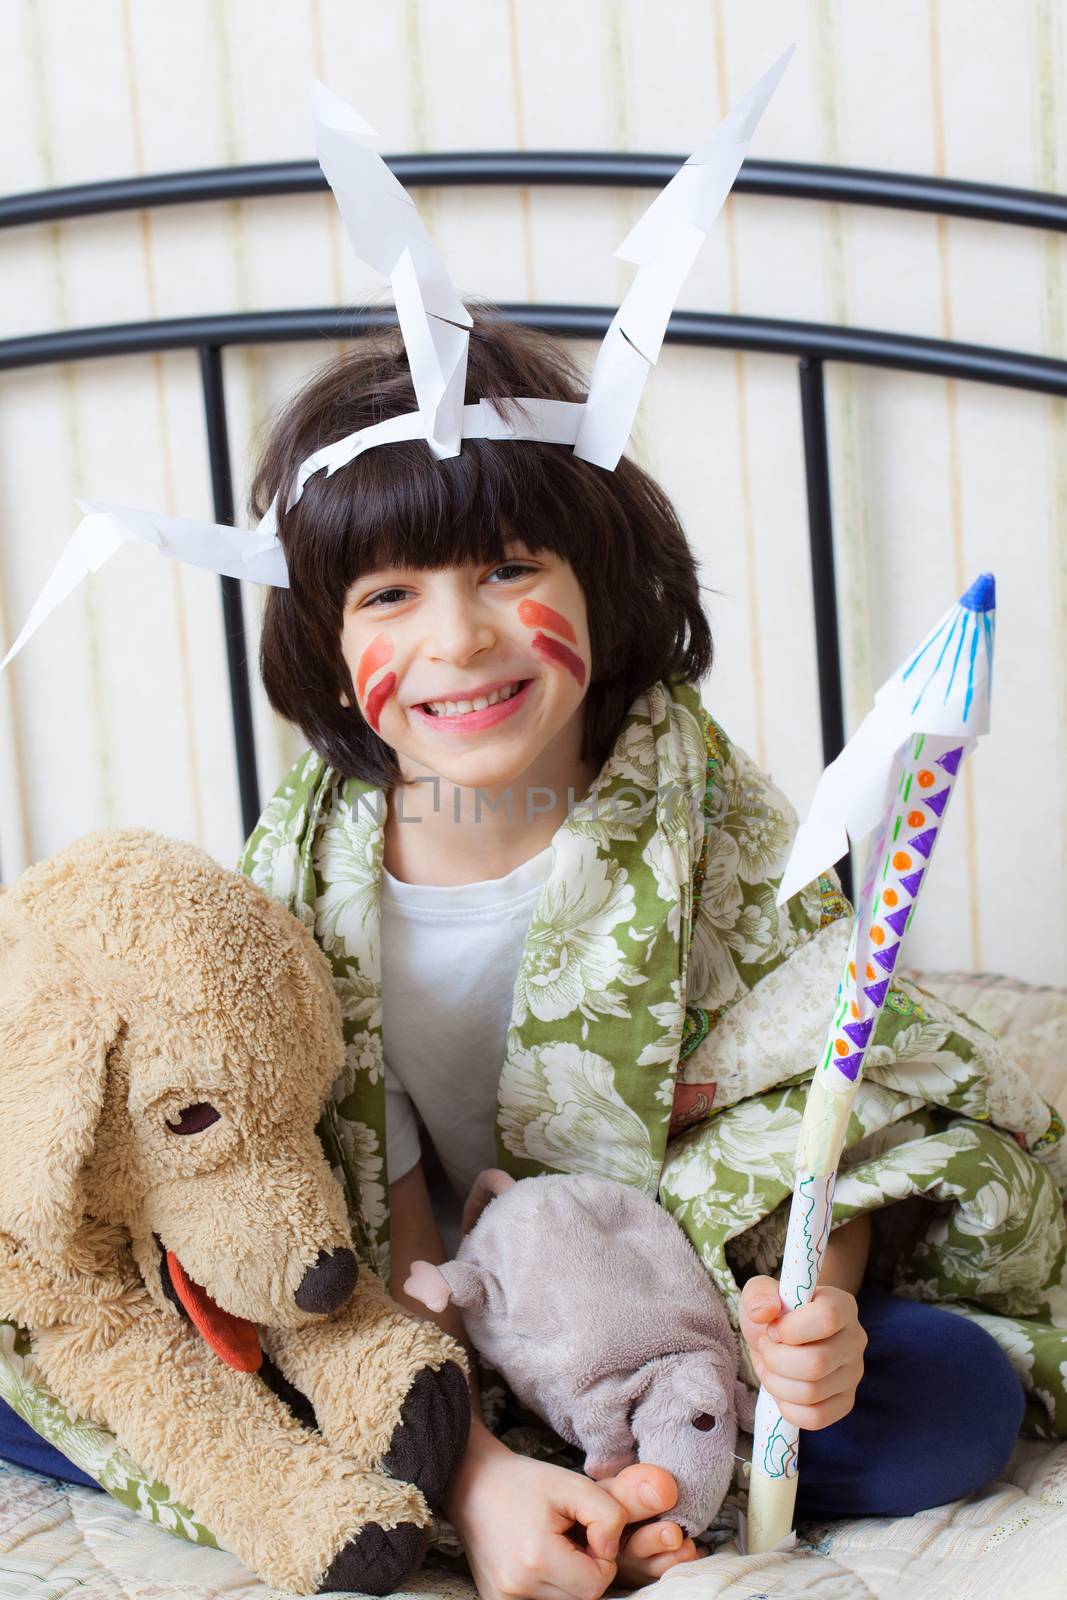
left=0, top=0, right=1067, bottom=982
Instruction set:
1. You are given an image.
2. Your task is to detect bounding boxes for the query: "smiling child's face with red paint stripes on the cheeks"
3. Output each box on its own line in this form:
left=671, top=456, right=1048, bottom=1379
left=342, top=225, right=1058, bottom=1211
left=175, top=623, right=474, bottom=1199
left=341, top=539, right=592, bottom=789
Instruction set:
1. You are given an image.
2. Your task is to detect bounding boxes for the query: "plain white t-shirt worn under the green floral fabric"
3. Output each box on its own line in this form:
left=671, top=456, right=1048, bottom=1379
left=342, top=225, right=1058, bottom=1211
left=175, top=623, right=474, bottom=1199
left=381, top=846, right=552, bottom=1251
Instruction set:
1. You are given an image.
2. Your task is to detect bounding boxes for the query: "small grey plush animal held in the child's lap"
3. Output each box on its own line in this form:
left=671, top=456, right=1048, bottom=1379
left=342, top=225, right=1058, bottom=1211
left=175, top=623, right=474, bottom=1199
left=405, top=1171, right=755, bottom=1536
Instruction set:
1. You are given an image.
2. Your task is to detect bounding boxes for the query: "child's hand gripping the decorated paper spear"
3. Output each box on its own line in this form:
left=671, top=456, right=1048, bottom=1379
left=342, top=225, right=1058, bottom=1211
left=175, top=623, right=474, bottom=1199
left=741, top=1278, right=867, bottom=1432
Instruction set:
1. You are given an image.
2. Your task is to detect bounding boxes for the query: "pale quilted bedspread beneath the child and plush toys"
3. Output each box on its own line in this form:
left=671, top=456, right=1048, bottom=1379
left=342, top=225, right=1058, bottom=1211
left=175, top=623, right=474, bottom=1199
left=0, top=1442, right=1067, bottom=1600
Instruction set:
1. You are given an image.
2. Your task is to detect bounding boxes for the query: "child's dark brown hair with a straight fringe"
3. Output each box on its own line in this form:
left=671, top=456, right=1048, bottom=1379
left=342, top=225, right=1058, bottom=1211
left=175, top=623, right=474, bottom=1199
left=251, top=307, right=712, bottom=787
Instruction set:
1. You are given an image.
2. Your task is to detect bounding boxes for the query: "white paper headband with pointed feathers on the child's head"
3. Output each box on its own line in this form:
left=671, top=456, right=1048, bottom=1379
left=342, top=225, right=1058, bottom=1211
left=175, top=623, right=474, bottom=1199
left=0, top=45, right=793, bottom=672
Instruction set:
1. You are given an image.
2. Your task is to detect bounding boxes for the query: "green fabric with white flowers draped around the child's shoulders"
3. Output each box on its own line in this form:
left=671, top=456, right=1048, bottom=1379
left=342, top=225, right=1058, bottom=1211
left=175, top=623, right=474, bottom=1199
left=0, top=685, right=1067, bottom=1539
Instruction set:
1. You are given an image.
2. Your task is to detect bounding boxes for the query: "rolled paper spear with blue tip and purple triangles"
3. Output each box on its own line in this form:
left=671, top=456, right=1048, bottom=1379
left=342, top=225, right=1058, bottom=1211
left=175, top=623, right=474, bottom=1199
left=747, top=573, right=997, bottom=1554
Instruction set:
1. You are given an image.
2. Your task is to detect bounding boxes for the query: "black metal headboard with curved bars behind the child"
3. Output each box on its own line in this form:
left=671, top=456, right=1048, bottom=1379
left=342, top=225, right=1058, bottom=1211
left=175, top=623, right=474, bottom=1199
left=0, top=150, right=1067, bottom=908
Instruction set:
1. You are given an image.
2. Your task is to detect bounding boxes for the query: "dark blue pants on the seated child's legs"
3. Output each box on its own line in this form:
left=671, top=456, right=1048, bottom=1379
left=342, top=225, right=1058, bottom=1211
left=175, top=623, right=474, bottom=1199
left=0, top=1290, right=1024, bottom=1520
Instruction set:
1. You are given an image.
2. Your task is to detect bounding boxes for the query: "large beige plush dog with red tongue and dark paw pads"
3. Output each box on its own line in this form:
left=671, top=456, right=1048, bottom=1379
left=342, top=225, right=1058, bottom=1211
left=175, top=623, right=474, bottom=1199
left=0, top=832, right=469, bottom=1594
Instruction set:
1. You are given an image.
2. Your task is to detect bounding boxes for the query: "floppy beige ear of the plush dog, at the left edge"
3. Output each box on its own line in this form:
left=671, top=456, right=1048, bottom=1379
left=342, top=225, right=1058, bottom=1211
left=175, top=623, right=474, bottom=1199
left=0, top=915, right=122, bottom=1256
